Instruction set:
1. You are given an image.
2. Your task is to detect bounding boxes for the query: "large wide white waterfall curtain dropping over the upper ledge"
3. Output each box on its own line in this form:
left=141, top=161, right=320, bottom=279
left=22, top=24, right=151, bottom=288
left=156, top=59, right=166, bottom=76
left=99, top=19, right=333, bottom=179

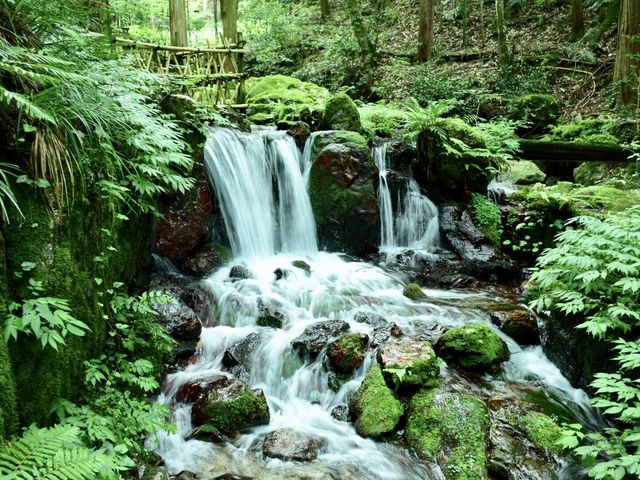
left=204, top=128, right=318, bottom=258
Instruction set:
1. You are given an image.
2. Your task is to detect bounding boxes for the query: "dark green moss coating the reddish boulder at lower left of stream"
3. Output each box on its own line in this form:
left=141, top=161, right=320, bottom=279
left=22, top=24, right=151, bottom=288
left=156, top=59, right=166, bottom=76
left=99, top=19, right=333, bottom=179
left=205, top=390, right=269, bottom=434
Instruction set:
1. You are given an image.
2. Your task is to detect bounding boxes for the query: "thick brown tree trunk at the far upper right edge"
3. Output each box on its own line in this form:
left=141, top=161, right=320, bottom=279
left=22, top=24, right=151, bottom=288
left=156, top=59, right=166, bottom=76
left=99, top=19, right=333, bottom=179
left=613, top=0, right=640, bottom=106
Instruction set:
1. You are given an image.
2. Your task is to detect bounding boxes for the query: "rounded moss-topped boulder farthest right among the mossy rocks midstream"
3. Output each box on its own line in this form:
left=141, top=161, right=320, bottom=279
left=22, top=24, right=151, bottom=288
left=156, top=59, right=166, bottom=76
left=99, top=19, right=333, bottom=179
left=437, top=323, right=509, bottom=371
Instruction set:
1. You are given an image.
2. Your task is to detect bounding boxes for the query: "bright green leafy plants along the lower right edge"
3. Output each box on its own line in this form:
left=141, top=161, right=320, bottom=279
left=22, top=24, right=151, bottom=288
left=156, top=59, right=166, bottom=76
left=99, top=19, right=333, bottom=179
left=532, top=206, right=640, bottom=480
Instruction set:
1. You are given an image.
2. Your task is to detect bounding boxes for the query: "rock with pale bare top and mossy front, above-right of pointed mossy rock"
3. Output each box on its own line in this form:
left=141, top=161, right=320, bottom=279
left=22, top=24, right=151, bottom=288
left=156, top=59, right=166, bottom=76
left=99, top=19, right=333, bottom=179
left=377, top=338, right=440, bottom=390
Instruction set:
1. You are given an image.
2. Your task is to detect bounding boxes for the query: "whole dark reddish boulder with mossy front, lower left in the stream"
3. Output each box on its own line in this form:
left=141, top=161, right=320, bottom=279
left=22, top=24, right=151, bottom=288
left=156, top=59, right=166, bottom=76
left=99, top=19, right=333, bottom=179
left=189, top=377, right=270, bottom=435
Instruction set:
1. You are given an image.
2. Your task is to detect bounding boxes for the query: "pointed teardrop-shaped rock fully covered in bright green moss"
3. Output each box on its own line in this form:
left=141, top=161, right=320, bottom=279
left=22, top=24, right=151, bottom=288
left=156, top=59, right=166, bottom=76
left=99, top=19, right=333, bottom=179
left=349, top=364, right=404, bottom=438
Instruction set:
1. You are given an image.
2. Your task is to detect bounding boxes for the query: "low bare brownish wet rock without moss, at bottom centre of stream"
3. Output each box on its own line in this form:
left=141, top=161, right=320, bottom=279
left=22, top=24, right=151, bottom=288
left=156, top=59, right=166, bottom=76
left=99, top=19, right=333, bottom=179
left=262, top=428, right=325, bottom=462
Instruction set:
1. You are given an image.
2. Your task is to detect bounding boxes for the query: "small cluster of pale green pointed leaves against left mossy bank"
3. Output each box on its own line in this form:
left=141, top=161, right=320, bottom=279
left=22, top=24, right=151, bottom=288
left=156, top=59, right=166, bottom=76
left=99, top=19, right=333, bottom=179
left=4, top=278, right=90, bottom=351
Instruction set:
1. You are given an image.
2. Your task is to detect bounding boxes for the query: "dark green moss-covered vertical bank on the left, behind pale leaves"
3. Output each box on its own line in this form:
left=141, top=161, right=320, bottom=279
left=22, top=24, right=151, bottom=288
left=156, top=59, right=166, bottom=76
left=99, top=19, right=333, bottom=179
left=0, top=184, right=153, bottom=435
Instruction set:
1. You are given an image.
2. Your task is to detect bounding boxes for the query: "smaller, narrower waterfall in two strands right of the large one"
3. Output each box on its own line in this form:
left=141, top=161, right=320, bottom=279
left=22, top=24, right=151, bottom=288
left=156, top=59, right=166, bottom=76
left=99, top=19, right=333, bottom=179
left=373, top=143, right=440, bottom=253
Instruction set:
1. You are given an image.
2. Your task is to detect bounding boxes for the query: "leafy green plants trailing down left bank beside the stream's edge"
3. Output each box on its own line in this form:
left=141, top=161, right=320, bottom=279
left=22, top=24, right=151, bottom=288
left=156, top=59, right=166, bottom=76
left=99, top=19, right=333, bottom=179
left=56, top=284, right=175, bottom=468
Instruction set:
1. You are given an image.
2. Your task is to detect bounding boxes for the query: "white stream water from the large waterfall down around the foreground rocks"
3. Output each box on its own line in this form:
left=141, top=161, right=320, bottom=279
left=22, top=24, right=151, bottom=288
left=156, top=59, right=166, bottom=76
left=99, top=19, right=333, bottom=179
left=157, top=129, right=592, bottom=480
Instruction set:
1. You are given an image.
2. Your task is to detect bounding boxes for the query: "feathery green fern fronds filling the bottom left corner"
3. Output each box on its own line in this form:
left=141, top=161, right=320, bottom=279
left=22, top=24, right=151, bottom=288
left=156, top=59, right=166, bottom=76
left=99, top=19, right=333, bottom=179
left=0, top=425, right=117, bottom=480
